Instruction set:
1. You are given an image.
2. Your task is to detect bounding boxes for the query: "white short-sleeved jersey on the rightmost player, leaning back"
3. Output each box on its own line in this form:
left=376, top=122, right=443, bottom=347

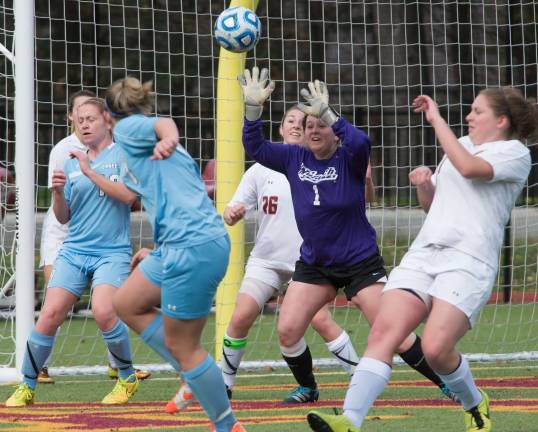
left=411, top=136, right=531, bottom=268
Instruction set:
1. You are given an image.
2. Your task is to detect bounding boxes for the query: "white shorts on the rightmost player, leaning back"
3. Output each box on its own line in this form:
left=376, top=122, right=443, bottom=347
left=383, top=245, right=497, bottom=327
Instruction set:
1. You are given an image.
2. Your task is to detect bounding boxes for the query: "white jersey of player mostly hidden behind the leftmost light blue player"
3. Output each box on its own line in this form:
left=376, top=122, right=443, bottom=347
left=40, top=133, right=86, bottom=266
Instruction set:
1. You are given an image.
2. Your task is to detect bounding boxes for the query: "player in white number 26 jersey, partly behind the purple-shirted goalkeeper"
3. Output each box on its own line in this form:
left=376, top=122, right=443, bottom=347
left=166, top=106, right=366, bottom=413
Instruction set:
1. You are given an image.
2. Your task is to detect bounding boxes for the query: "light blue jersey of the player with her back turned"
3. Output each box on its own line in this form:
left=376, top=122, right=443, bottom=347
left=114, top=114, right=226, bottom=248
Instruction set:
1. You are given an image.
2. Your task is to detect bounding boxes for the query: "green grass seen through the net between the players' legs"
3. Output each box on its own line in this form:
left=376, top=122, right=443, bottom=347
left=0, top=303, right=538, bottom=367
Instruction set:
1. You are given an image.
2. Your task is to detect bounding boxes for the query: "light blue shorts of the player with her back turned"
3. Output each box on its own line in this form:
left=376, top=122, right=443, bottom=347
left=160, top=235, right=230, bottom=320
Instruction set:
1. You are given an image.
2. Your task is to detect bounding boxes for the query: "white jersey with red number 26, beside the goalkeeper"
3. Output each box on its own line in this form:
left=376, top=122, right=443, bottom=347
left=228, top=163, right=303, bottom=272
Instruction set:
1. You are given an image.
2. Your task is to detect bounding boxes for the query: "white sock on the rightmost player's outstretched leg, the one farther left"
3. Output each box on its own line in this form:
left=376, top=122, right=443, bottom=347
left=344, top=357, right=392, bottom=427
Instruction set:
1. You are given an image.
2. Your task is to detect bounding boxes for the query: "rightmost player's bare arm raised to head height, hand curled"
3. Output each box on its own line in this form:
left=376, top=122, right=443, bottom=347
left=413, top=95, right=494, bottom=180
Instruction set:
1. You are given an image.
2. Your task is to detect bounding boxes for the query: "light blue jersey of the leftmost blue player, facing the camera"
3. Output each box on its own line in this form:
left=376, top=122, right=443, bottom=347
left=62, top=143, right=131, bottom=256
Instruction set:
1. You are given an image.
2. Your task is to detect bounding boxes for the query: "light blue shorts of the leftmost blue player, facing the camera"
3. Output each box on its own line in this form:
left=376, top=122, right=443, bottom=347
left=47, top=248, right=131, bottom=297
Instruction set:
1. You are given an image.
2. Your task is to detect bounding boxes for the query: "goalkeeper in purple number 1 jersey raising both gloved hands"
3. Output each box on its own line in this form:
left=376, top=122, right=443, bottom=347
left=240, top=67, right=452, bottom=401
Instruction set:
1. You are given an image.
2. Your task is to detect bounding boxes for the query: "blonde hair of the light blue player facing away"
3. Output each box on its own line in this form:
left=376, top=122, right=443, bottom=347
left=105, top=77, right=153, bottom=117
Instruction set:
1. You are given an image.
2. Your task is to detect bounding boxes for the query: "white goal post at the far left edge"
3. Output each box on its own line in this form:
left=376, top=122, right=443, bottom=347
left=0, top=0, right=35, bottom=382
